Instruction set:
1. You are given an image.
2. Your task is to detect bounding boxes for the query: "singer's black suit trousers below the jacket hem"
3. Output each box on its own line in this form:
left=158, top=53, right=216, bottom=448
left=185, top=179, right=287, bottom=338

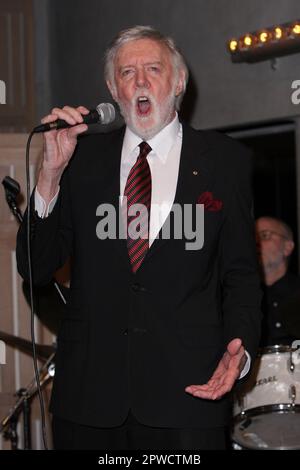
left=52, top=411, right=226, bottom=450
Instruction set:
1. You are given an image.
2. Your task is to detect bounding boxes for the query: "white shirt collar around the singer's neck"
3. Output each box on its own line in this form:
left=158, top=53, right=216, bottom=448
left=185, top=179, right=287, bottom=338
left=123, top=113, right=180, bottom=163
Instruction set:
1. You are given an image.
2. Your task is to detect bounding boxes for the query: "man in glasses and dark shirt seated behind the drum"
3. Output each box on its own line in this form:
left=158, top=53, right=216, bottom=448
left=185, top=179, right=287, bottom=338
left=256, top=217, right=300, bottom=346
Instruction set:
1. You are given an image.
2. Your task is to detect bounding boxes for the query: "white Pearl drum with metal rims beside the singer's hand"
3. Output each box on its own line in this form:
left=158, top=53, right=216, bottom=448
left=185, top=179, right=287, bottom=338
left=233, top=346, right=300, bottom=450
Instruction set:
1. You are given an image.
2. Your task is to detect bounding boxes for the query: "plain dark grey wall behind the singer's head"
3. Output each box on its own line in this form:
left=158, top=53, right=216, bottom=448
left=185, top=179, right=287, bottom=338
left=34, top=0, right=300, bottom=128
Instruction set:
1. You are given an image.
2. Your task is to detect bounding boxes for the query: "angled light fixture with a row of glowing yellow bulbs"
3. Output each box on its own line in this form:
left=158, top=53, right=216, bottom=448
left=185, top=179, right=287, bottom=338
left=228, top=20, right=300, bottom=62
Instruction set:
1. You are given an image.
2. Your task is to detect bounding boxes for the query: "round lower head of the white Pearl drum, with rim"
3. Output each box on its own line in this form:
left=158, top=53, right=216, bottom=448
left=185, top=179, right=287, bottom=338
left=233, top=404, right=300, bottom=450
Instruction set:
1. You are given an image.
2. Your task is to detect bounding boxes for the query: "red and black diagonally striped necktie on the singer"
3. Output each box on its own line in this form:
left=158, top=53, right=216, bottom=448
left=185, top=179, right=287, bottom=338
left=124, top=142, right=151, bottom=273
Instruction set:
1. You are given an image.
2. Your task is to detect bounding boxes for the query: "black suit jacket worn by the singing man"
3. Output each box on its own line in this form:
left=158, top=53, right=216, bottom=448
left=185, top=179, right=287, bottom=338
left=17, top=125, right=260, bottom=427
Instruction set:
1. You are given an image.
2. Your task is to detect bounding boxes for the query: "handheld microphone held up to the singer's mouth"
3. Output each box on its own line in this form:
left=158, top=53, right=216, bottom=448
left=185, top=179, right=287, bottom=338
left=33, top=103, right=116, bottom=133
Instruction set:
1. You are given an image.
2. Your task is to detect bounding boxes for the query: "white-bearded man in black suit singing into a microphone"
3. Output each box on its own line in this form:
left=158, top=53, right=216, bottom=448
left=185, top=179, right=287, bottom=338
left=17, top=26, right=260, bottom=449
